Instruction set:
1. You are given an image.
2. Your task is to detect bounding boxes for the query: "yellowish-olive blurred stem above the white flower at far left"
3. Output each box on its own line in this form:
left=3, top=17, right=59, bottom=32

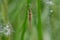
left=1, top=0, right=8, bottom=24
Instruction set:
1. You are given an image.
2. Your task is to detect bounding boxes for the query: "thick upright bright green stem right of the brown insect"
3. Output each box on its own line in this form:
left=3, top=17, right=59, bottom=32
left=37, top=0, right=43, bottom=40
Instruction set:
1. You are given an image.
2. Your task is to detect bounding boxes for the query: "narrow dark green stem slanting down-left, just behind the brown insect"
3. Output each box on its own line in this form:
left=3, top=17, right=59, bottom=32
left=21, top=0, right=29, bottom=40
